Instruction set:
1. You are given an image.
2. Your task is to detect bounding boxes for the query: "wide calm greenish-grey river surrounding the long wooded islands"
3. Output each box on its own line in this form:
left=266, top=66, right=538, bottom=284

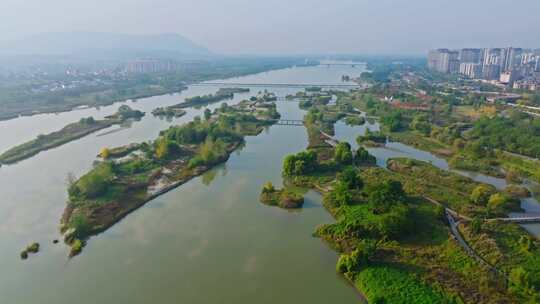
left=0, top=67, right=368, bottom=303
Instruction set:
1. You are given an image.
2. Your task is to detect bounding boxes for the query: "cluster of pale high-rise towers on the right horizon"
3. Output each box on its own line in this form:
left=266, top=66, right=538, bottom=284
left=428, top=47, right=540, bottom=91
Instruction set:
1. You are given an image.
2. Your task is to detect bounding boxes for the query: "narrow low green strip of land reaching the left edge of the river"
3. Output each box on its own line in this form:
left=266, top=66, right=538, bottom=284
left=0, top=105, right=144, bottom=164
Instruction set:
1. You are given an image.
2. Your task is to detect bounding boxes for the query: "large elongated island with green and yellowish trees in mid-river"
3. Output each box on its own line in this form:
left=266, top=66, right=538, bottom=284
left=61, top=101, right=279, bottom=255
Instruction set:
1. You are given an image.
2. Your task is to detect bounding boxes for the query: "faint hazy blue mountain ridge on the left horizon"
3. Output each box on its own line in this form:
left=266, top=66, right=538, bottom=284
left=0, top=32, right=211, bottom=57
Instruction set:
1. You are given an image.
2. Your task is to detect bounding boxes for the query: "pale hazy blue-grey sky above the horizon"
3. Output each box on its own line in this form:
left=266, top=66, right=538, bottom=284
left=0, top=0, right=540, bottom=54
